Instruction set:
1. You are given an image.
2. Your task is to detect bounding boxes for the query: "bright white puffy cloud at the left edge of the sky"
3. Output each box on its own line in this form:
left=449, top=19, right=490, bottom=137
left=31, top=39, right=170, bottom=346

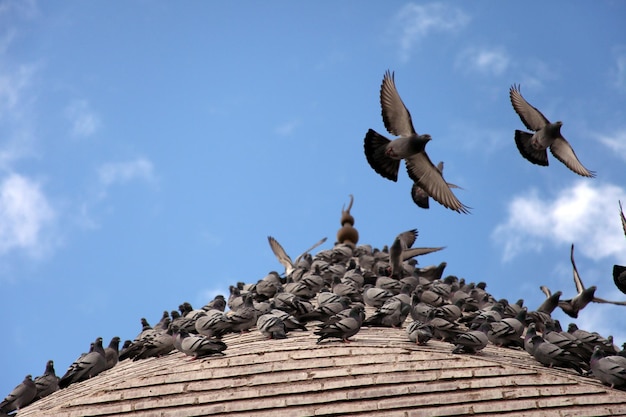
left=0, top=174, right=56, bottom=256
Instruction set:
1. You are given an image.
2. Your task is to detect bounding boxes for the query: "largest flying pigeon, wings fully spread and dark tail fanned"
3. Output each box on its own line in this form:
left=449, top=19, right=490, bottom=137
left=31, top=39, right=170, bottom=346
left=363, top=71, right=469, bottom=213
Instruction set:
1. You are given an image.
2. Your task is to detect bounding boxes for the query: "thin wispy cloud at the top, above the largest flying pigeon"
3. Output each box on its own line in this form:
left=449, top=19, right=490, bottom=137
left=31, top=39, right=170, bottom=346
left=393, top=3, right=470, bottom=60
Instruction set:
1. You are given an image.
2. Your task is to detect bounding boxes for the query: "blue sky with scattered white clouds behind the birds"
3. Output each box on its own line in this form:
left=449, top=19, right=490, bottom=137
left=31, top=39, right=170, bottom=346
left=0, top=0, right=626, bottom=396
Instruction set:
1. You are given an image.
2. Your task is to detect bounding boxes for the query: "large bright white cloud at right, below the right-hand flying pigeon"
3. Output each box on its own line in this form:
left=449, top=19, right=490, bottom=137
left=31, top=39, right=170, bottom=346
left=492, top=180, right=626, bottom=261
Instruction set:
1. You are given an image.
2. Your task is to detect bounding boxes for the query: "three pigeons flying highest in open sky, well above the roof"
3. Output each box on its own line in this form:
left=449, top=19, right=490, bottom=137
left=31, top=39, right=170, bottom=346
left=363, top=71, right=595, bottom=214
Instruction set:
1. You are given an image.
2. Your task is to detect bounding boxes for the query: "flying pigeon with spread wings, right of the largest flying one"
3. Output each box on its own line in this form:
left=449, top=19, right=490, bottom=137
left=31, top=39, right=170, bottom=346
left=509, top=85, right=596, bottom=177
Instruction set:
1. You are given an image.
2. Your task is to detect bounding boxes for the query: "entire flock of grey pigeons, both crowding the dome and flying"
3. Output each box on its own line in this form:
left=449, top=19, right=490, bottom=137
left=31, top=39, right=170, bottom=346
left=0, top=71, right=626, bottom=415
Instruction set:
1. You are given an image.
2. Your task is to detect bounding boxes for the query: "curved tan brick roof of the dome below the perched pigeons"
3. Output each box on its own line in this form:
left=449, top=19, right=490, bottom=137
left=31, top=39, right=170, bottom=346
left=18, top=316, right=626, bottom=417
